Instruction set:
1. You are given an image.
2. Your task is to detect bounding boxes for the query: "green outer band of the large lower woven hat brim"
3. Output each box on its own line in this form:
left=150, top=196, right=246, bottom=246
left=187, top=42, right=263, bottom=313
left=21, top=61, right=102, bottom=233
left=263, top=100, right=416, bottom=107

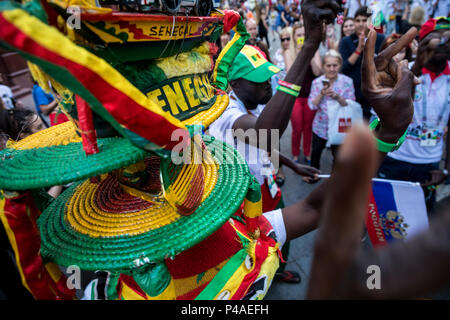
left=38, top=136, right=251, bottom=272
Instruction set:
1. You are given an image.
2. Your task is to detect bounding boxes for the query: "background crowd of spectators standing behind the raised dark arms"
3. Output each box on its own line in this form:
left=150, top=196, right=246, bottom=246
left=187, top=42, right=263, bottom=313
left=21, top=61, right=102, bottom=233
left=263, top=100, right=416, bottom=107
left=224, top=0, right=449, bottom=214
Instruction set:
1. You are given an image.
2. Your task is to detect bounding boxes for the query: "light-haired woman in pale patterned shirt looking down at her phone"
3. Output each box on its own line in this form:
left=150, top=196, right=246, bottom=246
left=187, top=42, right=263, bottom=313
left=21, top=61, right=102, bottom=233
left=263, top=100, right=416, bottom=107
left=308, top=50, right=355, bottom=169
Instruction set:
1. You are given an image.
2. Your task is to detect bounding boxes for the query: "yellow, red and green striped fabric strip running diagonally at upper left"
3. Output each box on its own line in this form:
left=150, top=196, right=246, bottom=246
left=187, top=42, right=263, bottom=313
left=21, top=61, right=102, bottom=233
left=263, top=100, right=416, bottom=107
left=0, top=9, right=189, bottom=150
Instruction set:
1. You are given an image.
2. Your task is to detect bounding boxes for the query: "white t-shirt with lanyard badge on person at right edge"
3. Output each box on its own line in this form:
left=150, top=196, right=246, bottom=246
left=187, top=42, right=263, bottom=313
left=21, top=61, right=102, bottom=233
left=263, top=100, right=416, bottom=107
left=388, top=62, right=450, bottom=164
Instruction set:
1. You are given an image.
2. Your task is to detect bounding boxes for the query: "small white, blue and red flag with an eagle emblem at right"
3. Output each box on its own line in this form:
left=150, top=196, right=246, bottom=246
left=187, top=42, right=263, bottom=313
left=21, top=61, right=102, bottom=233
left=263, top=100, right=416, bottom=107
left=366, top=179, right=428, bottom=247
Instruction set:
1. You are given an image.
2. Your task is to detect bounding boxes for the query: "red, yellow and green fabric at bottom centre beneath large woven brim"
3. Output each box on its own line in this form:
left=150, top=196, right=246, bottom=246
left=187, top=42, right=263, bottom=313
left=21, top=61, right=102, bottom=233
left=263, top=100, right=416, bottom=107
left=109, top=217, right=278, bottom=300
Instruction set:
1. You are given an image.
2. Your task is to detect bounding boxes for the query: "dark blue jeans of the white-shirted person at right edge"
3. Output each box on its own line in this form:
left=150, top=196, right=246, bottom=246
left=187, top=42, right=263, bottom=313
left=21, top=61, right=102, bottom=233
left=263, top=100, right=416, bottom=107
left=378, top=156, right=439, bottom=212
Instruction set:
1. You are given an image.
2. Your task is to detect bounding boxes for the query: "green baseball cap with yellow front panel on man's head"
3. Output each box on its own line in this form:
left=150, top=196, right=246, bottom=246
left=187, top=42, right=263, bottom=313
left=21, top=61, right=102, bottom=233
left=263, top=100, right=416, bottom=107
left=228, top=45, right=281, bottom=83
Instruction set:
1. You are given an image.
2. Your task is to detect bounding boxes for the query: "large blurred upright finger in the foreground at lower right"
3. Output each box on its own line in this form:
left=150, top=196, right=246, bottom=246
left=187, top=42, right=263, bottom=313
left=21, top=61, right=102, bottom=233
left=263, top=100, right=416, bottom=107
left=307, top=125, right=377, bottom=299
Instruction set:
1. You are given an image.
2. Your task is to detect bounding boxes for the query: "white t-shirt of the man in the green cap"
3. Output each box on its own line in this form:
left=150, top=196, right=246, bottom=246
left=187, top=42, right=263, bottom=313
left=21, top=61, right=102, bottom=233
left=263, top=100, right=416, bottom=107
left=208, top=92, right=274, bottom=185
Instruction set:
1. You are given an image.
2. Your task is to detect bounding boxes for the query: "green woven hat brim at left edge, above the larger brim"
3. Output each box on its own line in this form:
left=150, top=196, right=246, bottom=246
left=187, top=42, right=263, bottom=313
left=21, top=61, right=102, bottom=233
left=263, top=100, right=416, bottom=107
left=0, top=138, right=149, bottom=190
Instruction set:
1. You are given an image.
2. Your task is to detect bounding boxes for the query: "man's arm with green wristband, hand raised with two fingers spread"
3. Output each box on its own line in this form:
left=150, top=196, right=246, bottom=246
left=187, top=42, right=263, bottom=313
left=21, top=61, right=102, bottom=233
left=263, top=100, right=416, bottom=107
left=283, top=29, right=416, bottom=248
